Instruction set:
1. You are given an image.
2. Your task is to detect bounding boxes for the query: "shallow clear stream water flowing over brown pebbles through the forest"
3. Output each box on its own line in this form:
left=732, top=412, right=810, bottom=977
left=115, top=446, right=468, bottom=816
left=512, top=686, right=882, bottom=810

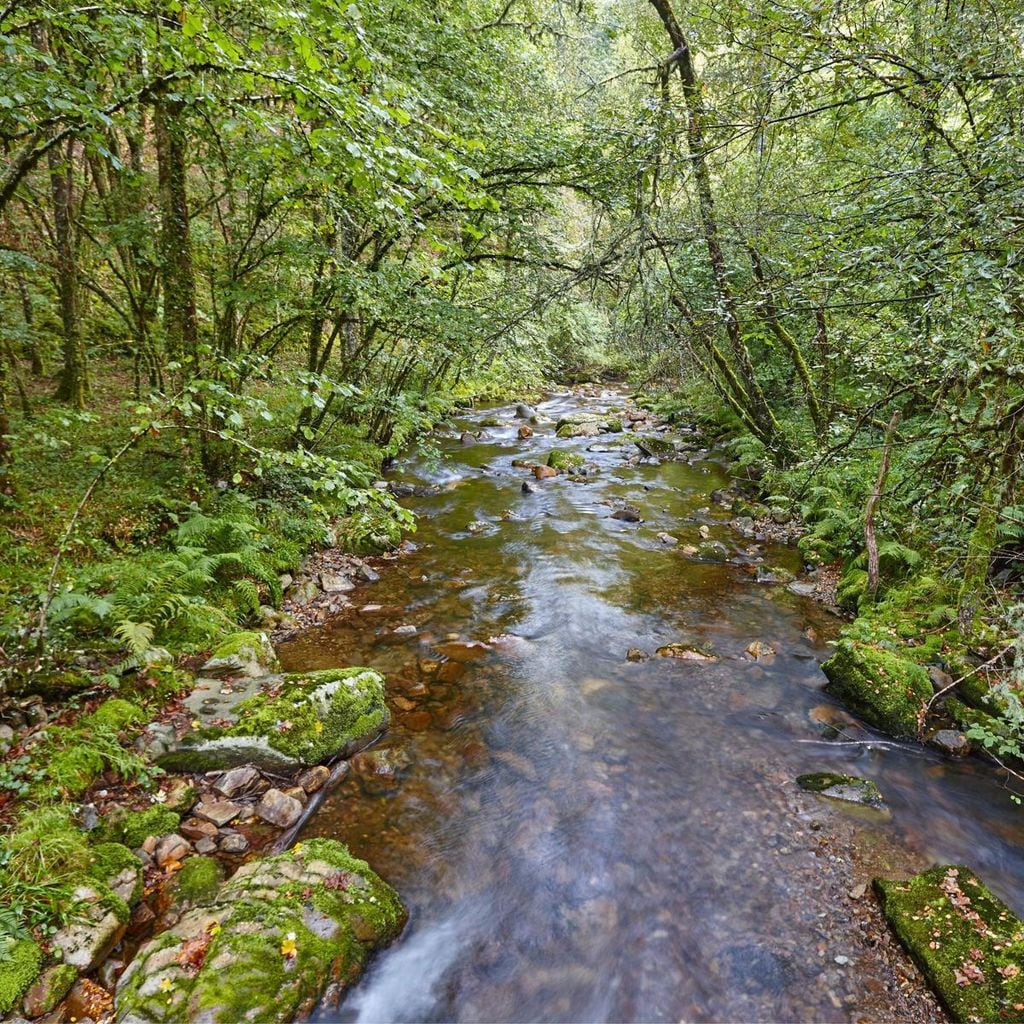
left=282, top=392, right=1024, bottom=1021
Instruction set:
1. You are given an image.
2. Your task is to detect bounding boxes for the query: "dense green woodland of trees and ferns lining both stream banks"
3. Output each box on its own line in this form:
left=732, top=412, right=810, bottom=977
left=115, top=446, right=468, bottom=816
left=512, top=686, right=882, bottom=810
left=0, top=0, right=1024, bottom=1007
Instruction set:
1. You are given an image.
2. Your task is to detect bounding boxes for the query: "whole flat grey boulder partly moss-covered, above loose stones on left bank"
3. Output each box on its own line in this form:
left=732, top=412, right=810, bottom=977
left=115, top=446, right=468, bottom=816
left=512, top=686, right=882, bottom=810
left=159, top=669, right=389, bottom=771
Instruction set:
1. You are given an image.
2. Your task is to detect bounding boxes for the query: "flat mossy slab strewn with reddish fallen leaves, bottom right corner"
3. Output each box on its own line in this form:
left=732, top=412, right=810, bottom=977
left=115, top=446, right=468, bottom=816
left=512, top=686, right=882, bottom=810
left=874, top=865, right=1024, bottom=1021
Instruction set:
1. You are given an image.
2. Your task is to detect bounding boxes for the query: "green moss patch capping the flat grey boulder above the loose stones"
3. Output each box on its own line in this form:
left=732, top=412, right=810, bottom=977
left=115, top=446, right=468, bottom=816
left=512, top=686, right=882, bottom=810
left=221, top=668, right=388, bottom=764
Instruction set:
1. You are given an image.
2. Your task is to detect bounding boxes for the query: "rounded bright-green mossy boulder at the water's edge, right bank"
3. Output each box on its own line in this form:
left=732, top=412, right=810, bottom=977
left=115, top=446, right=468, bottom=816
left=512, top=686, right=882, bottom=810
left=821, top=640, right=932, bottom=738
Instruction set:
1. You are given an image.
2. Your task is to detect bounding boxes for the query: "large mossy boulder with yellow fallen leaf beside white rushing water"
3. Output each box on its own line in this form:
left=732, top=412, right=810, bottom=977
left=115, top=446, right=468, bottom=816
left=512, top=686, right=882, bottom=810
left=116, top=840, right=406, bottom=1024
